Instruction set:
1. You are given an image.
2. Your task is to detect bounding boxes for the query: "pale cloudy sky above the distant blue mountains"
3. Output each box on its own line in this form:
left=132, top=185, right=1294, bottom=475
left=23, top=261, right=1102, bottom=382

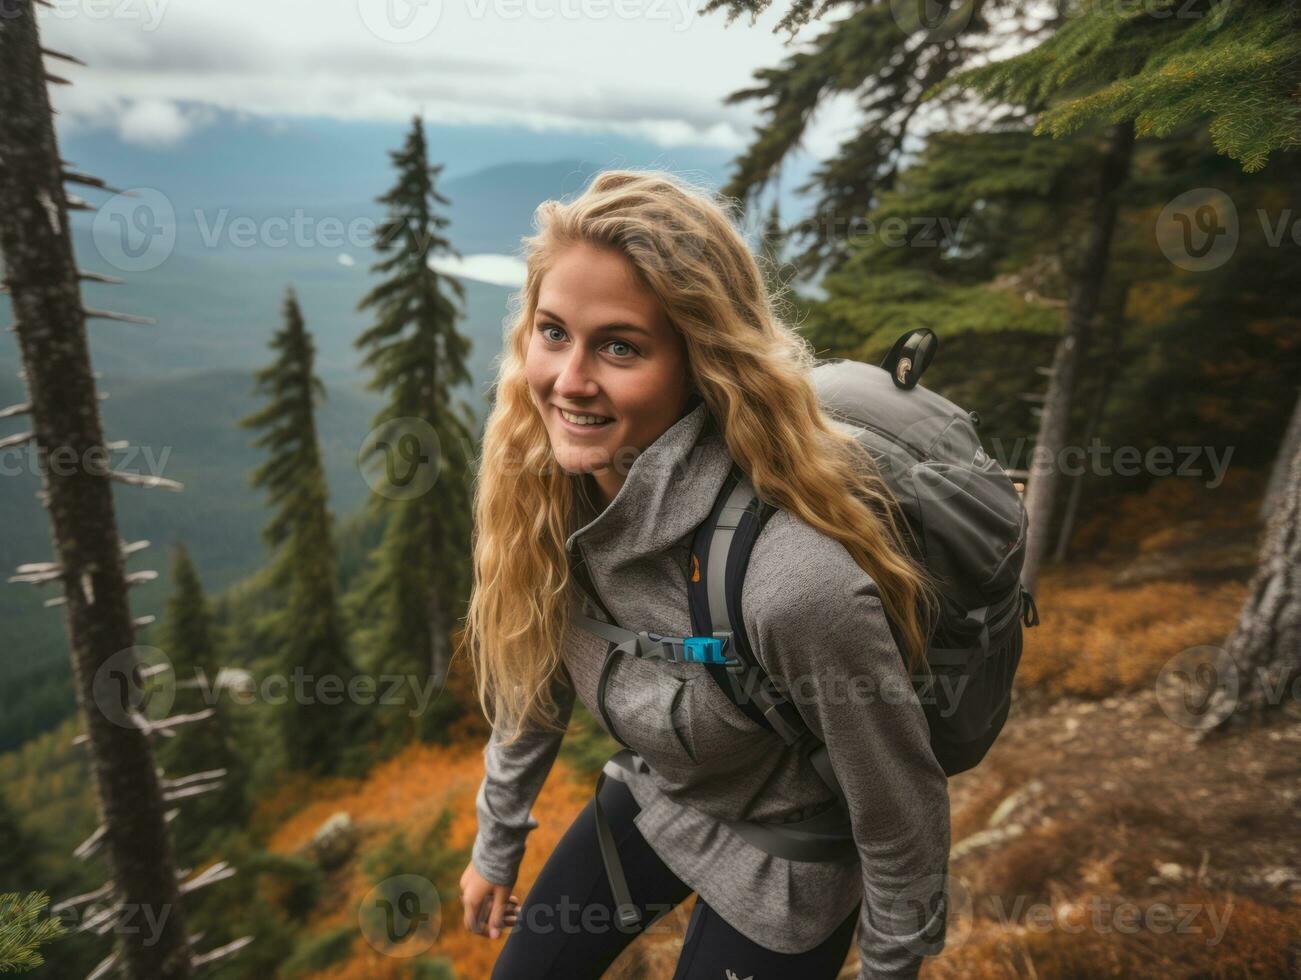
left=38, top=0, right=853, bottom=159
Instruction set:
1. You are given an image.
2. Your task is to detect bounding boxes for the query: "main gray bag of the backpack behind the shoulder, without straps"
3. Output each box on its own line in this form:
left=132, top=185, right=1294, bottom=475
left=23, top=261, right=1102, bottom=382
left=796, top=329, right=1039, bottom=776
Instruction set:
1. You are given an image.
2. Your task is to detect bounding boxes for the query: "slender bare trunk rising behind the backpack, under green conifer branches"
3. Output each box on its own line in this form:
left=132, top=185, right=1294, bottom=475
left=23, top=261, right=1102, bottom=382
left=1021, top=122, right=1134, bottom=592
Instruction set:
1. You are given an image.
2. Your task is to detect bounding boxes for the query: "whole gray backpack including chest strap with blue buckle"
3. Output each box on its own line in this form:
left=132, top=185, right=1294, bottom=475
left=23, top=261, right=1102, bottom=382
left=572, top=329, right=1039, bottom=915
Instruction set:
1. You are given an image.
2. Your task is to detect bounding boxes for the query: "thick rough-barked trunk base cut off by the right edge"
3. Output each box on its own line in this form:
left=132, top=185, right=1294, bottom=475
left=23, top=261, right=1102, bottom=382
left=1200, top=419, right=1301, bottom=738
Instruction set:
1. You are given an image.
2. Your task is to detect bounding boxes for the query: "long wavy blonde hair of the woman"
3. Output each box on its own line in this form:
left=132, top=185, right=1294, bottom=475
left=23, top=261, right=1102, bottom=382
left=458, top=170, right=938, bottom=744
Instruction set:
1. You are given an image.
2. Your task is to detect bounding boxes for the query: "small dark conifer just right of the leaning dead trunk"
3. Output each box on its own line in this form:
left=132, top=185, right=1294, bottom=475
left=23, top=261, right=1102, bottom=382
left=159, top=544, right=248, bottom=864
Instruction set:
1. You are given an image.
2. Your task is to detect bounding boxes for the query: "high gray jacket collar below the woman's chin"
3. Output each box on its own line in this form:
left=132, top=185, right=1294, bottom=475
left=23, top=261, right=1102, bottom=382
left=565, top=401, right=732, bottom=566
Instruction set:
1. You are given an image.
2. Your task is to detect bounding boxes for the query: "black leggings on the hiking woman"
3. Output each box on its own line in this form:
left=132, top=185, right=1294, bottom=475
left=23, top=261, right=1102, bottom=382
left=492, top=778, right=859, bottom=980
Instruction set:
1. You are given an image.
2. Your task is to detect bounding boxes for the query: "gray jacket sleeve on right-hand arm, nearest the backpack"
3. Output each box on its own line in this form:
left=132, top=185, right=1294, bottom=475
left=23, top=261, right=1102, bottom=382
left=743, top=524, right=950, bottom=980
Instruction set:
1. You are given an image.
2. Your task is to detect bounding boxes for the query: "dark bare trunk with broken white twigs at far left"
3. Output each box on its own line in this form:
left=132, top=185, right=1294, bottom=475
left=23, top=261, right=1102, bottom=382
left=0, top=0, right=190, bottom=980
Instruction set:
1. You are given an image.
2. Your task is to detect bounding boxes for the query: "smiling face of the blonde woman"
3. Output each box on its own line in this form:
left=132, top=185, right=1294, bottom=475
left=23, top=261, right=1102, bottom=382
left=524, top=245, right=691, bottom=504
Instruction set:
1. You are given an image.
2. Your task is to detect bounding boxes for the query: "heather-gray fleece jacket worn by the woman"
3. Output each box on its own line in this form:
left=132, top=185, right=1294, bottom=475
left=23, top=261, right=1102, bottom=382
left=472, top=402, right=950, bottom=980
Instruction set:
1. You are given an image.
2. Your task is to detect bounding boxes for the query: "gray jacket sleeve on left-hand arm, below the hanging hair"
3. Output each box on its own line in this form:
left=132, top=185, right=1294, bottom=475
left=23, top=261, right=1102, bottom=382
left=470, top=666, right=574, bottom=885
